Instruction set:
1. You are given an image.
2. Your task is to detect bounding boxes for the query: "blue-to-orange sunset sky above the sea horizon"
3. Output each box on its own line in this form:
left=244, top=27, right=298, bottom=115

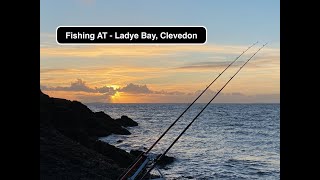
left=40, top=0, right=280, bottom=103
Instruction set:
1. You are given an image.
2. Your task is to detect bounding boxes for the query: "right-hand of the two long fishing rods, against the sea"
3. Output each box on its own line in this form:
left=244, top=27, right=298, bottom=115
left=140, top=43, right=268, bottom=180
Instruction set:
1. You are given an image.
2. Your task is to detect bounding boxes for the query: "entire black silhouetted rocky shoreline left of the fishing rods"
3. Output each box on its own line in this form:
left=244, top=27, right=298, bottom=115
left=40, top=91, right=173, bottom=180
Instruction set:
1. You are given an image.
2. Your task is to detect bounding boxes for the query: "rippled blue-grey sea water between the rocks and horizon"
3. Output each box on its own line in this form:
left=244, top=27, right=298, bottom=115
left=88, top=104, right=280, bottom=179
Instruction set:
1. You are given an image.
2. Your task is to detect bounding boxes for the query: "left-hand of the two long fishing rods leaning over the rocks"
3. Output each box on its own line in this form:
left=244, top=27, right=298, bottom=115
left=118, top=41, right=258, bottom=180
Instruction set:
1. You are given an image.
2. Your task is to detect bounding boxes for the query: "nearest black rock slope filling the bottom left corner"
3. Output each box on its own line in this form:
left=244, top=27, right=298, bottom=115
left=40, top=116, right=124, bottom=180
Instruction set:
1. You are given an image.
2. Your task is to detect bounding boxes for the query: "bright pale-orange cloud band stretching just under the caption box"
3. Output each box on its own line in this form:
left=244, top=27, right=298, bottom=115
left=40, top=38, right=279, bottom=59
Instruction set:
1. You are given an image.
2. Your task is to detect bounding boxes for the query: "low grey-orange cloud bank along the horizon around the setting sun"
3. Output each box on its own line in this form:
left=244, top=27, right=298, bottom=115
left=40, top=79, right=280, bottom=103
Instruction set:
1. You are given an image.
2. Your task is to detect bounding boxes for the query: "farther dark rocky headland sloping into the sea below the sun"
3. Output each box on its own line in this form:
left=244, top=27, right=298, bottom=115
left=40, top=90, right=131, bottom=141
